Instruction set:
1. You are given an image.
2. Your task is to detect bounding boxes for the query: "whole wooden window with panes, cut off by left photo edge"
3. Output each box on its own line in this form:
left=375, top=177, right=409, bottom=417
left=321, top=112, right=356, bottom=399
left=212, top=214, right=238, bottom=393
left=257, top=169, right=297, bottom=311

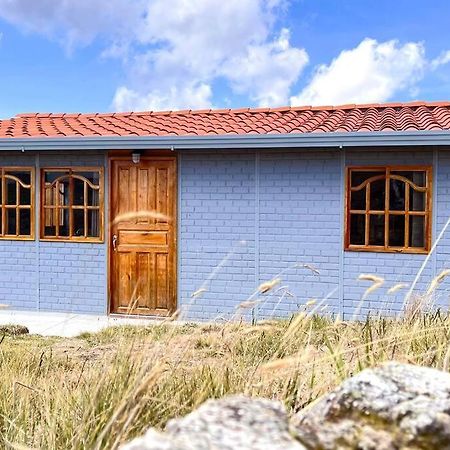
left=0, top=167, right=34, bottom=240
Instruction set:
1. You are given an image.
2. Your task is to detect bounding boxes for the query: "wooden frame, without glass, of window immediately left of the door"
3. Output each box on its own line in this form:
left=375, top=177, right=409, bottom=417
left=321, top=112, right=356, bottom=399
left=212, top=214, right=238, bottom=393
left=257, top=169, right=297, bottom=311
left=39, top=166, right=105, bottom=244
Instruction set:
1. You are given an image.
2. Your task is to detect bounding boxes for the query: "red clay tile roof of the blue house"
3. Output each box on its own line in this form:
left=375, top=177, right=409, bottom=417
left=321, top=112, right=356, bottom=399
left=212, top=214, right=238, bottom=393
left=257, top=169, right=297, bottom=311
left=0, top=102, right=450, bottom=138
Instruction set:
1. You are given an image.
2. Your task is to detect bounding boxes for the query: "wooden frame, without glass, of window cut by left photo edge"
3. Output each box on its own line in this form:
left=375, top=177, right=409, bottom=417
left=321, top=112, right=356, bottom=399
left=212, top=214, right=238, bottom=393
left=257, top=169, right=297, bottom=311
left=0, top=166, right=36, bottom=241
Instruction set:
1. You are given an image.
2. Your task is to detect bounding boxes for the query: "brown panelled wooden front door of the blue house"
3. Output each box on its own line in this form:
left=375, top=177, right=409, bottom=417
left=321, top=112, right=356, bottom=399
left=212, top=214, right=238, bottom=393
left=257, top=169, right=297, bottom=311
left=110, top=156, right=176, bottom=315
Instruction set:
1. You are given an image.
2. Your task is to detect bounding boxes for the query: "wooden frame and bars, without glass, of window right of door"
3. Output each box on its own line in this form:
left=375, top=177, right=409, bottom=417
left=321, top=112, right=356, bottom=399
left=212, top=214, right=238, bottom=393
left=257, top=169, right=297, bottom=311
left=344, top=165, right=433, bottom=254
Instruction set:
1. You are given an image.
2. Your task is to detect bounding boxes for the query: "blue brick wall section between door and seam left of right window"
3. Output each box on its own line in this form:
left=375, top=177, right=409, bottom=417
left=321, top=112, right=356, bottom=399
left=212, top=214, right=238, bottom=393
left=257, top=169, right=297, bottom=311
left=179, top=152, right=340, bottom=319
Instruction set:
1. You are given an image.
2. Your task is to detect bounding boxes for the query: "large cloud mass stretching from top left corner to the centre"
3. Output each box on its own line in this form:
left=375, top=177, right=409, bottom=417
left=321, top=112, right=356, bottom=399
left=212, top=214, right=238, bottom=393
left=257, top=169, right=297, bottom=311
left=0, top=0, right=308, bottom=110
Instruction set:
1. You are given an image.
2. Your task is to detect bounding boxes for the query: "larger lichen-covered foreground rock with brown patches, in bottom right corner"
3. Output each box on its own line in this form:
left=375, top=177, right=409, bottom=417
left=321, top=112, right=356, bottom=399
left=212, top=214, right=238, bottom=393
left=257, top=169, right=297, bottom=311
left=291, top=363, right=450, bottom=450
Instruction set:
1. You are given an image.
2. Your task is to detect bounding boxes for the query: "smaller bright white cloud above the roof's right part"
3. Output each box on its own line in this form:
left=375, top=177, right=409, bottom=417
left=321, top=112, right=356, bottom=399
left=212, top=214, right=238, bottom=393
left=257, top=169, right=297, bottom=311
left=291, top=39, right=426, bottom=105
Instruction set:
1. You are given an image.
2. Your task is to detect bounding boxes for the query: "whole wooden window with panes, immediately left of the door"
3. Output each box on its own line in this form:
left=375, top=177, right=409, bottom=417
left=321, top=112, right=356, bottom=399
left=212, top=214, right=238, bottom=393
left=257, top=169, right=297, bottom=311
left=41, top=167, right=103, bottom=242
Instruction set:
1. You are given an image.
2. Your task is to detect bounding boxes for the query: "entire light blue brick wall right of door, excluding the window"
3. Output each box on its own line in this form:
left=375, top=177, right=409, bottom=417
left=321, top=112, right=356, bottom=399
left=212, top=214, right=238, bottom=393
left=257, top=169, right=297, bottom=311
left=179, top=148, right=450, bottom=319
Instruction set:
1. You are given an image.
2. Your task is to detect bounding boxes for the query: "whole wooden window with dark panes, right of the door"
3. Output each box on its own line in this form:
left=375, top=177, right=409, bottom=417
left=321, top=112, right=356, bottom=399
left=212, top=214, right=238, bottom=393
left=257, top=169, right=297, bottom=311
left=345, top=166, right=431, bottom=253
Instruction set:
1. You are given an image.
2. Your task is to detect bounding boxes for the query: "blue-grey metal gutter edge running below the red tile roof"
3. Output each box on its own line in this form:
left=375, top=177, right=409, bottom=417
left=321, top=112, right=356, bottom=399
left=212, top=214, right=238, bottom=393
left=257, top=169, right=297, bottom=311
left=0, top=130, right=450, bottom=151
